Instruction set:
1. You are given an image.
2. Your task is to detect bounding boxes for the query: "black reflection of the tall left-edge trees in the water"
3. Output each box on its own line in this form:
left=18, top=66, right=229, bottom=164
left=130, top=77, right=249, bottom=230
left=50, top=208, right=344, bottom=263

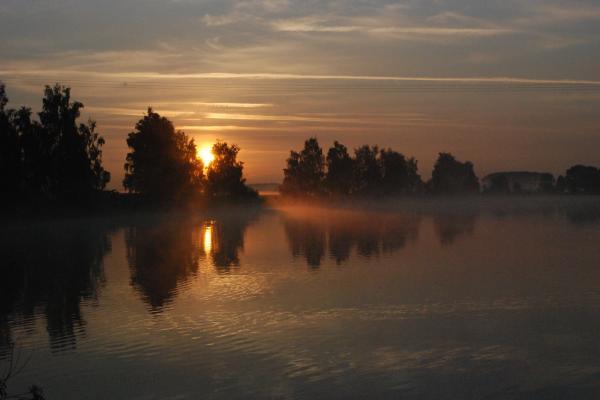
left=0, top=221, right=112, bottom=357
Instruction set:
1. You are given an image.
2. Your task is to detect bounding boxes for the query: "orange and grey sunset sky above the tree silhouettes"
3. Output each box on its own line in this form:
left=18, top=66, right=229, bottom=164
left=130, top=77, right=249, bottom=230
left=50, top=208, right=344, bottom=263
left=0, top=0, right=600, bottom=189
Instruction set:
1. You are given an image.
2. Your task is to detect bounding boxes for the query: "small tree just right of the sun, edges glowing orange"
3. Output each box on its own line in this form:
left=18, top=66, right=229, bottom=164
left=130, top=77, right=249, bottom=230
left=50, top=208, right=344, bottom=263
left=206, top=142, right=257, bottom=198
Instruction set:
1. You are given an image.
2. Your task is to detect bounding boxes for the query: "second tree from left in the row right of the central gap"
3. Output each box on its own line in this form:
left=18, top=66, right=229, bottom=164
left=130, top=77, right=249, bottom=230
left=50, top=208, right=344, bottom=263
left=325, top=141, right=354, bottom=195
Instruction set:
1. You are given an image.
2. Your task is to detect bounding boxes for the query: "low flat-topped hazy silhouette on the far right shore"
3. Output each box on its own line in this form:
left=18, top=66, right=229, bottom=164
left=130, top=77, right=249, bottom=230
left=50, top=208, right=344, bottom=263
left=481, top=171, right=554, bottom=193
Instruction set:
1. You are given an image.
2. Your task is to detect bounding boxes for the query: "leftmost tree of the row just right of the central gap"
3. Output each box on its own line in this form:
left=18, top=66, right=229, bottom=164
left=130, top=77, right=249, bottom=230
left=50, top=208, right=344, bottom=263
left=280, top=137, right=325, bottom=196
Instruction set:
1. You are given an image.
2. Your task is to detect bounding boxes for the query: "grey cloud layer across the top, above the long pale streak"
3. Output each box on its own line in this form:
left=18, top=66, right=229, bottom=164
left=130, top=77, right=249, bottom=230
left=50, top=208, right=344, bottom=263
left=0, top=0, right=600, bottom=85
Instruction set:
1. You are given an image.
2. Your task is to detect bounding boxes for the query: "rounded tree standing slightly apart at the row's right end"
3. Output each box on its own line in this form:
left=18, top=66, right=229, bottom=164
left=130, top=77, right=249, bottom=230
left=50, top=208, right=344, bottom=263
left=429, top=153, right=479, bottom=194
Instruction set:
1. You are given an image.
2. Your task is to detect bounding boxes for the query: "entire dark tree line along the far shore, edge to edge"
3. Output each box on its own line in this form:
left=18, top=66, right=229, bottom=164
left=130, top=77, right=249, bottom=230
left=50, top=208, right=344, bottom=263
left=0, top=83, right=600, bottom=210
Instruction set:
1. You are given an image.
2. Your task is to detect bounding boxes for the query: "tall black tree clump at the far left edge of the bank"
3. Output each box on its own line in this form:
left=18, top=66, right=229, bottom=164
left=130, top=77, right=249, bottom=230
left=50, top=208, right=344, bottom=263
left=0, top=84, right=110, bottom=203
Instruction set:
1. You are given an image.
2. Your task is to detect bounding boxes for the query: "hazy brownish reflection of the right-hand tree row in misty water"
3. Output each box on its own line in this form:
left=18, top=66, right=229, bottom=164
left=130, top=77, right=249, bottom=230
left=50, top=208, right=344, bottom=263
left=281, top=202, right=600, bottom=268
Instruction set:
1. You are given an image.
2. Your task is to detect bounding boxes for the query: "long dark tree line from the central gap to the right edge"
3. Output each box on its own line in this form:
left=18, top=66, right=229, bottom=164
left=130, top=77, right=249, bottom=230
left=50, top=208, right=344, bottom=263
left=280, top=137, right=600, bottom=197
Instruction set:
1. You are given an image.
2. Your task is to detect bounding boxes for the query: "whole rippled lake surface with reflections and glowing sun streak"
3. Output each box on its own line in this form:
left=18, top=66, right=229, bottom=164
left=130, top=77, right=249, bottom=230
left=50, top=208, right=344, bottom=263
left=0, top=199, right=600, bottom=400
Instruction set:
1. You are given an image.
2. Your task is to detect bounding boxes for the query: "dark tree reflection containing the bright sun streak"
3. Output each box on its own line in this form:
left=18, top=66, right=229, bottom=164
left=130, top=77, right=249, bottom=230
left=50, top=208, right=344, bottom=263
left=125, top=208, right=258, bottom=311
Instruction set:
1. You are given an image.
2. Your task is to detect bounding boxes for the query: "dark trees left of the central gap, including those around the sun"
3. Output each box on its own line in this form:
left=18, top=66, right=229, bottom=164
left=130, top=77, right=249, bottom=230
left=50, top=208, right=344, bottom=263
left=0, top=82, right=257, bottom=211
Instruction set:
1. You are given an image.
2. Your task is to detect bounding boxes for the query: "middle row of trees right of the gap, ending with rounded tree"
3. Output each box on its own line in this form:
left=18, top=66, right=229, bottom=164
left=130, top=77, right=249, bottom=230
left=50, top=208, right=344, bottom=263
left=280, top=137, right=479, bottom=197
